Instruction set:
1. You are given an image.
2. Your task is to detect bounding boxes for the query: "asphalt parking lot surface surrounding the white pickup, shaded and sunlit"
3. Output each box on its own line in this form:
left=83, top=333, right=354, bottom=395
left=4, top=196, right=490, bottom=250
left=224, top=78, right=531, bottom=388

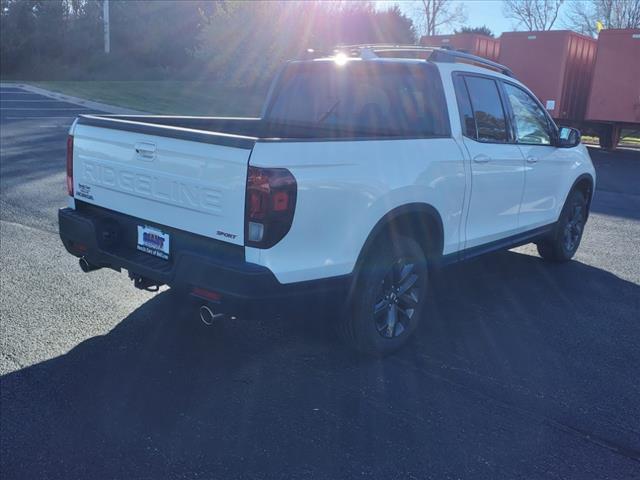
left=0, top=87, right=640, bottom=480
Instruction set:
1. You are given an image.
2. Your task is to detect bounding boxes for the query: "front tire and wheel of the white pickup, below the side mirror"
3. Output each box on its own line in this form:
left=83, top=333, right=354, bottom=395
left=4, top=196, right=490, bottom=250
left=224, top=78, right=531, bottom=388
left=537, top=190, right=588, bottom=262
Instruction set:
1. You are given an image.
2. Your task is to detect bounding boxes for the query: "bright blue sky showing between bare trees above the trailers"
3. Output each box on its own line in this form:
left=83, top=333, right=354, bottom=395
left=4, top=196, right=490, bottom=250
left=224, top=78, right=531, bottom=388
left=377, top=0, right=564, bottom=37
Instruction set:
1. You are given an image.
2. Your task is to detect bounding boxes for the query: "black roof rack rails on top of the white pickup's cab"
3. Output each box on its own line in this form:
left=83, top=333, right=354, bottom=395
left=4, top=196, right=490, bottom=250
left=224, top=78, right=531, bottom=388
left=334, top=43, right=514, bottom=77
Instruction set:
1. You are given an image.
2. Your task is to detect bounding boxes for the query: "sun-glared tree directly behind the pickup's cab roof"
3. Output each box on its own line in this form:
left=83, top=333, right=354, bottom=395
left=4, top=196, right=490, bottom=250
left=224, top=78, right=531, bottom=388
left=202, top=1, right=416, bottom=86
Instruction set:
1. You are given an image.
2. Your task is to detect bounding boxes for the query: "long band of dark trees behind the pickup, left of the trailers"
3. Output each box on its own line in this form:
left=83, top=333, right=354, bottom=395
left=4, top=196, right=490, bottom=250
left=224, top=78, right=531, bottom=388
left=0, top=0, right=416, bottom=80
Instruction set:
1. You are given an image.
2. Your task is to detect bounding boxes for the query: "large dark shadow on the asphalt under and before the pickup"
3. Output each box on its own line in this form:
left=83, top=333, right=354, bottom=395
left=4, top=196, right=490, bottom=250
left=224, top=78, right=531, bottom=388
left=1, top=252, right=640, bottom=478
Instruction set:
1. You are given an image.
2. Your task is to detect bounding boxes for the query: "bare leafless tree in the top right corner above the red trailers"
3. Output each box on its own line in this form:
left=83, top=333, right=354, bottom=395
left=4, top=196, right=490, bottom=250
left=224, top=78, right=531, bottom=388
left=563, top=0, right=640, bottom=36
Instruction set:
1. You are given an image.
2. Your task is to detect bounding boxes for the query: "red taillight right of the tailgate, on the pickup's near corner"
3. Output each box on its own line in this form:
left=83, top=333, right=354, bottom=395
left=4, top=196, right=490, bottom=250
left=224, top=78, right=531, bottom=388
left=244, top=167, right=298, bottom=248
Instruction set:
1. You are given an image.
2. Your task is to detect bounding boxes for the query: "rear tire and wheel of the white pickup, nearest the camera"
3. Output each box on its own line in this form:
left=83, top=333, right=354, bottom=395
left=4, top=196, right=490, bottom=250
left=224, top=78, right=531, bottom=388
left=338, top=235, right=428, bottom=356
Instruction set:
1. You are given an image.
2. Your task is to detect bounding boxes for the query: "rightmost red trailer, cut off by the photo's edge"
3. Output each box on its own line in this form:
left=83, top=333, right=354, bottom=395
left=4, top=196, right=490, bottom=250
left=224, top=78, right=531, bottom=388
left=586, top=29, right=640, bottom=149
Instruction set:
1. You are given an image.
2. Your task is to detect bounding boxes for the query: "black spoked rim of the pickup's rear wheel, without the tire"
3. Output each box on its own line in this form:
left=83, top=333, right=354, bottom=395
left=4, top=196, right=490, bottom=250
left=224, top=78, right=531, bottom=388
left=373, top=259, right=421, bottom=339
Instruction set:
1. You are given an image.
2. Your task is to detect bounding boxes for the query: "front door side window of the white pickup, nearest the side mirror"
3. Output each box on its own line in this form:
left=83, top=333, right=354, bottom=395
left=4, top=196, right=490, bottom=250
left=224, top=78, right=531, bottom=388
left=504, top=83, right=551, bottom=145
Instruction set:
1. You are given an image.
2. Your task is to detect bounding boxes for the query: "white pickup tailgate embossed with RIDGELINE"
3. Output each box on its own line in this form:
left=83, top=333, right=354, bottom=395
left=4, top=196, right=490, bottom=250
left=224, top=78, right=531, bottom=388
left=73, top=122, right=253, bottom=245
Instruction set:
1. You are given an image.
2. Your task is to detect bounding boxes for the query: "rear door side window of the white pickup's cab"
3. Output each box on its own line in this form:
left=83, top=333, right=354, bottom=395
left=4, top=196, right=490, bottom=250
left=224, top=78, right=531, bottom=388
left=464, top=76, right=509, bottom=143
